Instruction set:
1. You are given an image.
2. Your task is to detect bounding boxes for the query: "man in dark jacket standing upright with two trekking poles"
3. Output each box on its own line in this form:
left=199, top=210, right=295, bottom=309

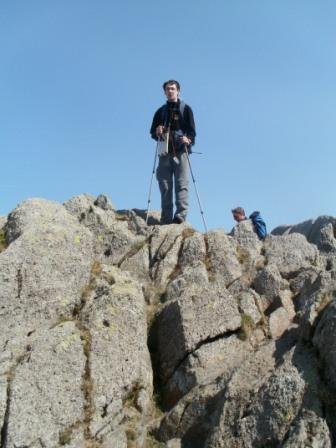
left=150, top=80, right=196, bottom=224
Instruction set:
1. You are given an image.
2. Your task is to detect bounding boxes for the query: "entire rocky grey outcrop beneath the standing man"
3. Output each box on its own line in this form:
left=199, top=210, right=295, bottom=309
left=0, top=194, right=336, bottom=448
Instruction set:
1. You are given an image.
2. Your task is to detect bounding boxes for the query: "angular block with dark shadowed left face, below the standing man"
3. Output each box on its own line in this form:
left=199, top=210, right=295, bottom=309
left=157, top=284, right=241, bottom=382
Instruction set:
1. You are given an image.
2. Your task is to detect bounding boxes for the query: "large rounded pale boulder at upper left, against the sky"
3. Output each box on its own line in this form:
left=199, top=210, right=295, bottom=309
left=0, top=199, right=94, bottom=364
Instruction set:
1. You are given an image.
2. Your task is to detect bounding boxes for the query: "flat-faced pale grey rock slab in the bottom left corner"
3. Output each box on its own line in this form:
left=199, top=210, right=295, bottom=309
left=3, top=322, right=86, bottom=448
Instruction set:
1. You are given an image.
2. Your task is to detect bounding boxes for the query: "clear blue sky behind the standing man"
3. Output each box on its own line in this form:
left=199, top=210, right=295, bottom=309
left=0, top=0, right=336, bottom=230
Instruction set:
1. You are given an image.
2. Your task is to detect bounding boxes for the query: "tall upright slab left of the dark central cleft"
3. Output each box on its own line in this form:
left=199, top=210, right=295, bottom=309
left=78, top=265, right=153, bottom=441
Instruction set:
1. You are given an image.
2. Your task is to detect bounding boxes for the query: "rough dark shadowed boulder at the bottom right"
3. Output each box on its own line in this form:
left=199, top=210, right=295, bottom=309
left=205, top=338, right=322, bottom=448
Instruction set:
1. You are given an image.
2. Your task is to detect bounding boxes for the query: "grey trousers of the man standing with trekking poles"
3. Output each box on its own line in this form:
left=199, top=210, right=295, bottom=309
left=156, top=152, right=188, bottom=224
